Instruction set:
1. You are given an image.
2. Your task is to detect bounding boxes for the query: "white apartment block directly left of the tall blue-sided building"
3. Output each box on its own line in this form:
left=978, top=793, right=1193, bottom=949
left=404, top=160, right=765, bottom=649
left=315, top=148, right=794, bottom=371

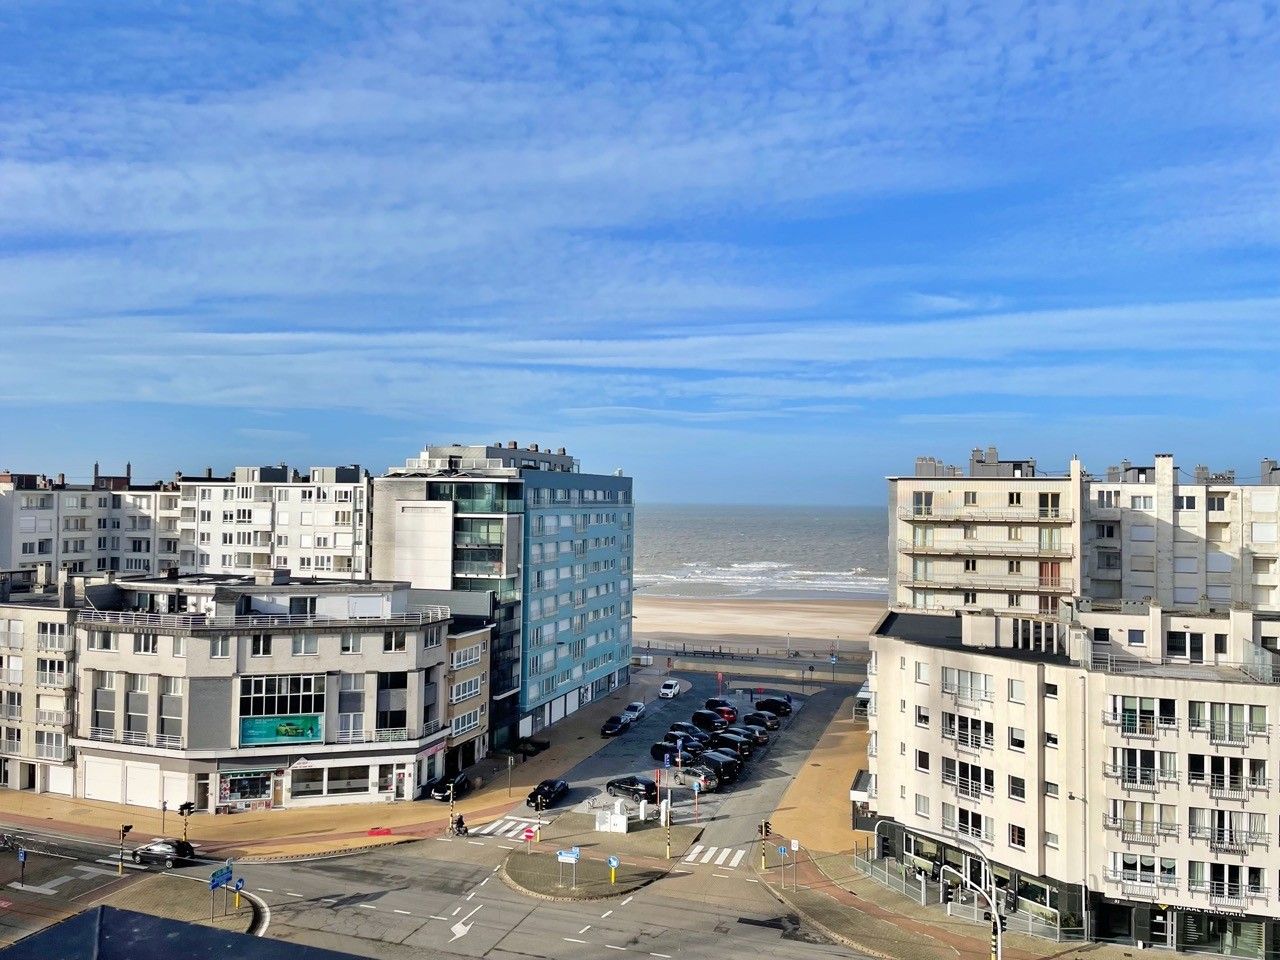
left=178, top=463, right=371, bottom=580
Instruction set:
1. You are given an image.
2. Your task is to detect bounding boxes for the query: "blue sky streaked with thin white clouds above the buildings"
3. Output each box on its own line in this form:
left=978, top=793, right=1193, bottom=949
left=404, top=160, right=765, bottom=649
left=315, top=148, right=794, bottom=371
left=0, top=0, right=1280, bottom=503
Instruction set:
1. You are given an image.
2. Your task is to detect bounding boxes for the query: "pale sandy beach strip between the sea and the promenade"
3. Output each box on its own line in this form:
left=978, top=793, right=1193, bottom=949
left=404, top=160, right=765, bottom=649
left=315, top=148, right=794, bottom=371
left=632, top=593, right=886, bottom=652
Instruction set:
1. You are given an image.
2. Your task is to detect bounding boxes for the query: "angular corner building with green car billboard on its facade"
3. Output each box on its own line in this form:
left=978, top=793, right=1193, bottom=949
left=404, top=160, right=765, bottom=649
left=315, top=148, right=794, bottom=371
left=64, top=570, right=449, bottom=812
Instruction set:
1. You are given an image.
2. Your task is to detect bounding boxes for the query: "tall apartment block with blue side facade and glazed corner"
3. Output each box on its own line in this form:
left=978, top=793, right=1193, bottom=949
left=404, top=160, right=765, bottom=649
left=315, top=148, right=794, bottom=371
left=372, top=442, right=634, bottom=745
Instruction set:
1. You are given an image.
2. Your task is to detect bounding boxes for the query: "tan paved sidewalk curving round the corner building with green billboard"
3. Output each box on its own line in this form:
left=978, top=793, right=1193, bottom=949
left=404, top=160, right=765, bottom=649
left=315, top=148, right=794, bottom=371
left=0, top=669, right=664, bottom=859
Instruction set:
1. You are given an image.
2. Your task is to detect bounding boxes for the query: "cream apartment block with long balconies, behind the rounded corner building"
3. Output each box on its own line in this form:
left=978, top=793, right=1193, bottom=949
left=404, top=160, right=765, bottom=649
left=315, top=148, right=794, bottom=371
left=888, top=448, right=1280, bottom=613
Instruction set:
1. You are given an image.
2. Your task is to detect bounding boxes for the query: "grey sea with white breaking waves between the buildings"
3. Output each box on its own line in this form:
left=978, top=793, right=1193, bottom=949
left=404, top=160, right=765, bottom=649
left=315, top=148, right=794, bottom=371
left=635, top=504, right=888, bottom=600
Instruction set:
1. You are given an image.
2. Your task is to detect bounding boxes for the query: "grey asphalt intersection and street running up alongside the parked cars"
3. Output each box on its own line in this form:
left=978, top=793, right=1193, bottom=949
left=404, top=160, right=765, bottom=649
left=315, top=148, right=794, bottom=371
left=204, top=675, right=858, bottom=960
